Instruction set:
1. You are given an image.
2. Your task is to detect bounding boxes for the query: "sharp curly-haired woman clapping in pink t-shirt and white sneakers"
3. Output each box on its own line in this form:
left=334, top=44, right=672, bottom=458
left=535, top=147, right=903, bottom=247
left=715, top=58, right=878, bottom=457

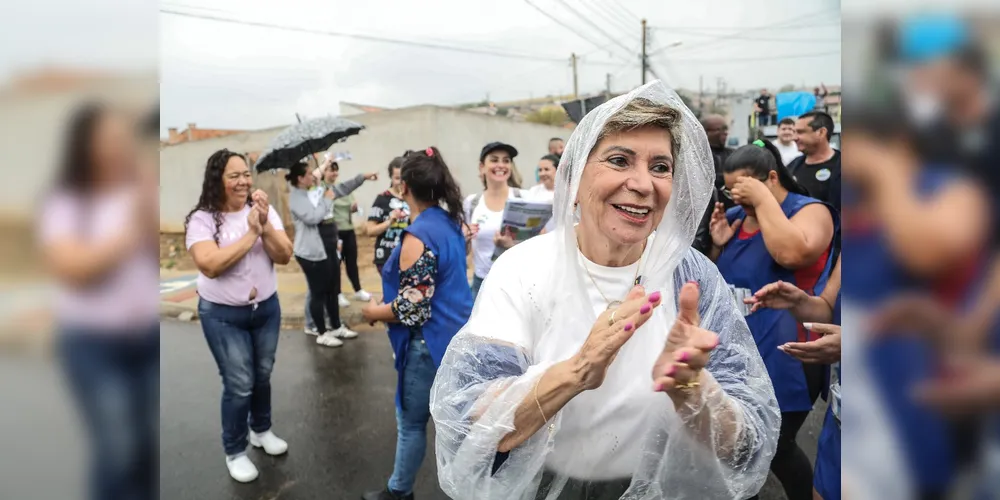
left=185, top=149, right=292, bottom=482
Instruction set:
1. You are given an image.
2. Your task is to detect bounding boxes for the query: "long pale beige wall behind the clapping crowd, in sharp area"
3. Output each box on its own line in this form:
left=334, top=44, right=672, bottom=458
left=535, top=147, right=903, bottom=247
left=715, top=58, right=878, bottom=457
left=160, top=106, right=570, bottom=231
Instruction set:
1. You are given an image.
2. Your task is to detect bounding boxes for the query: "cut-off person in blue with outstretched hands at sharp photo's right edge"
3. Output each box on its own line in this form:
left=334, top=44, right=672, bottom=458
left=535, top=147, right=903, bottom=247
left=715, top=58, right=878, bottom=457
left=744, top=258, right=841, bottom=500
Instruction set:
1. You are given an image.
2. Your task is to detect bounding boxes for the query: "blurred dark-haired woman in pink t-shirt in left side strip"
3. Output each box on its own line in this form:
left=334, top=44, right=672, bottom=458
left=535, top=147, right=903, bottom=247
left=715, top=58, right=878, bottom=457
left=39, top=104, right=160, bottom=498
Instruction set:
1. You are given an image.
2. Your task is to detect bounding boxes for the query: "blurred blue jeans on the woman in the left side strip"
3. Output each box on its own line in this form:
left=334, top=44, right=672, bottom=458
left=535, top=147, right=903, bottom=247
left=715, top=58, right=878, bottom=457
left=56, top=323, right=160, bottom=500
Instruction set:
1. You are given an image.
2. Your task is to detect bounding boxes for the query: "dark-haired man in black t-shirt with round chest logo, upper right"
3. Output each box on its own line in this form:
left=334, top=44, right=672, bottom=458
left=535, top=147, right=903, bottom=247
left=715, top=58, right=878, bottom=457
left=788, top=111, right=840, bottom=205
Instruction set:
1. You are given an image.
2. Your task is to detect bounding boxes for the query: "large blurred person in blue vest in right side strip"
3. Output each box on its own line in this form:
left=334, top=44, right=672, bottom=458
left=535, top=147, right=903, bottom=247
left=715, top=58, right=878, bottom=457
left=843, top=110, right=990, bottom=498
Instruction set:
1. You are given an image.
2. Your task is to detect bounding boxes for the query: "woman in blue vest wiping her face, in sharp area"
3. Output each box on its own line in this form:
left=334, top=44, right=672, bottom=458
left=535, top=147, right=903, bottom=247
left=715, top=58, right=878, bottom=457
left=709, top=141, right=838, bottom=500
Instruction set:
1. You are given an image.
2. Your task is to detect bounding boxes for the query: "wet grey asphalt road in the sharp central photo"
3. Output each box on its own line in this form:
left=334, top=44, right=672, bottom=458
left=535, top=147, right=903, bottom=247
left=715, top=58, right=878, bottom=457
left=160, top=322, right=447, bottom=500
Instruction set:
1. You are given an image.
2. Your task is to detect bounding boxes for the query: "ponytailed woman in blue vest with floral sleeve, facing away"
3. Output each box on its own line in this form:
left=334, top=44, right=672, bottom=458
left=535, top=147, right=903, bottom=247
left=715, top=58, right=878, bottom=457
left=362, top=147, right=473, bottom=500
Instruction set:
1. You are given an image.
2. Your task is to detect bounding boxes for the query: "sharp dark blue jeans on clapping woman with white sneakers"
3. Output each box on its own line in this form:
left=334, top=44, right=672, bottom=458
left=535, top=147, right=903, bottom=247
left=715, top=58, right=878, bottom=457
left=198, top=293, right=281, bottom=456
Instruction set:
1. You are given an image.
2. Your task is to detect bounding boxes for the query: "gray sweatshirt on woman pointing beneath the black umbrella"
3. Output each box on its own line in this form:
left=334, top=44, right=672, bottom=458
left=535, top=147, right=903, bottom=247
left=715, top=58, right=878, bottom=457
left=288, top=174, right=365, bottom=262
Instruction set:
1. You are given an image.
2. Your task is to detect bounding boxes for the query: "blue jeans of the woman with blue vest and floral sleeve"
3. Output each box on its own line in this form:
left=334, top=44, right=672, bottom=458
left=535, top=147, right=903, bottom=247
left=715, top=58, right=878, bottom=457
left=389, top=340, right=437, bottom=495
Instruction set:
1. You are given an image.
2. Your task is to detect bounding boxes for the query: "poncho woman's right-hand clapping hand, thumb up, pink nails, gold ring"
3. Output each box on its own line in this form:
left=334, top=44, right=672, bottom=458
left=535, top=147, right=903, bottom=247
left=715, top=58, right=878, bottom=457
left=653, top=282, right=719, bottom=405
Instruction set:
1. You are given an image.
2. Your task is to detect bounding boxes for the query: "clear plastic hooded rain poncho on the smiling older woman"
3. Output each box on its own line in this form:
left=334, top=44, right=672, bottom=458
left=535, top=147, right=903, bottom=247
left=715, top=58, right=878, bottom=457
left=431, top=81, right=781, bottom=500
